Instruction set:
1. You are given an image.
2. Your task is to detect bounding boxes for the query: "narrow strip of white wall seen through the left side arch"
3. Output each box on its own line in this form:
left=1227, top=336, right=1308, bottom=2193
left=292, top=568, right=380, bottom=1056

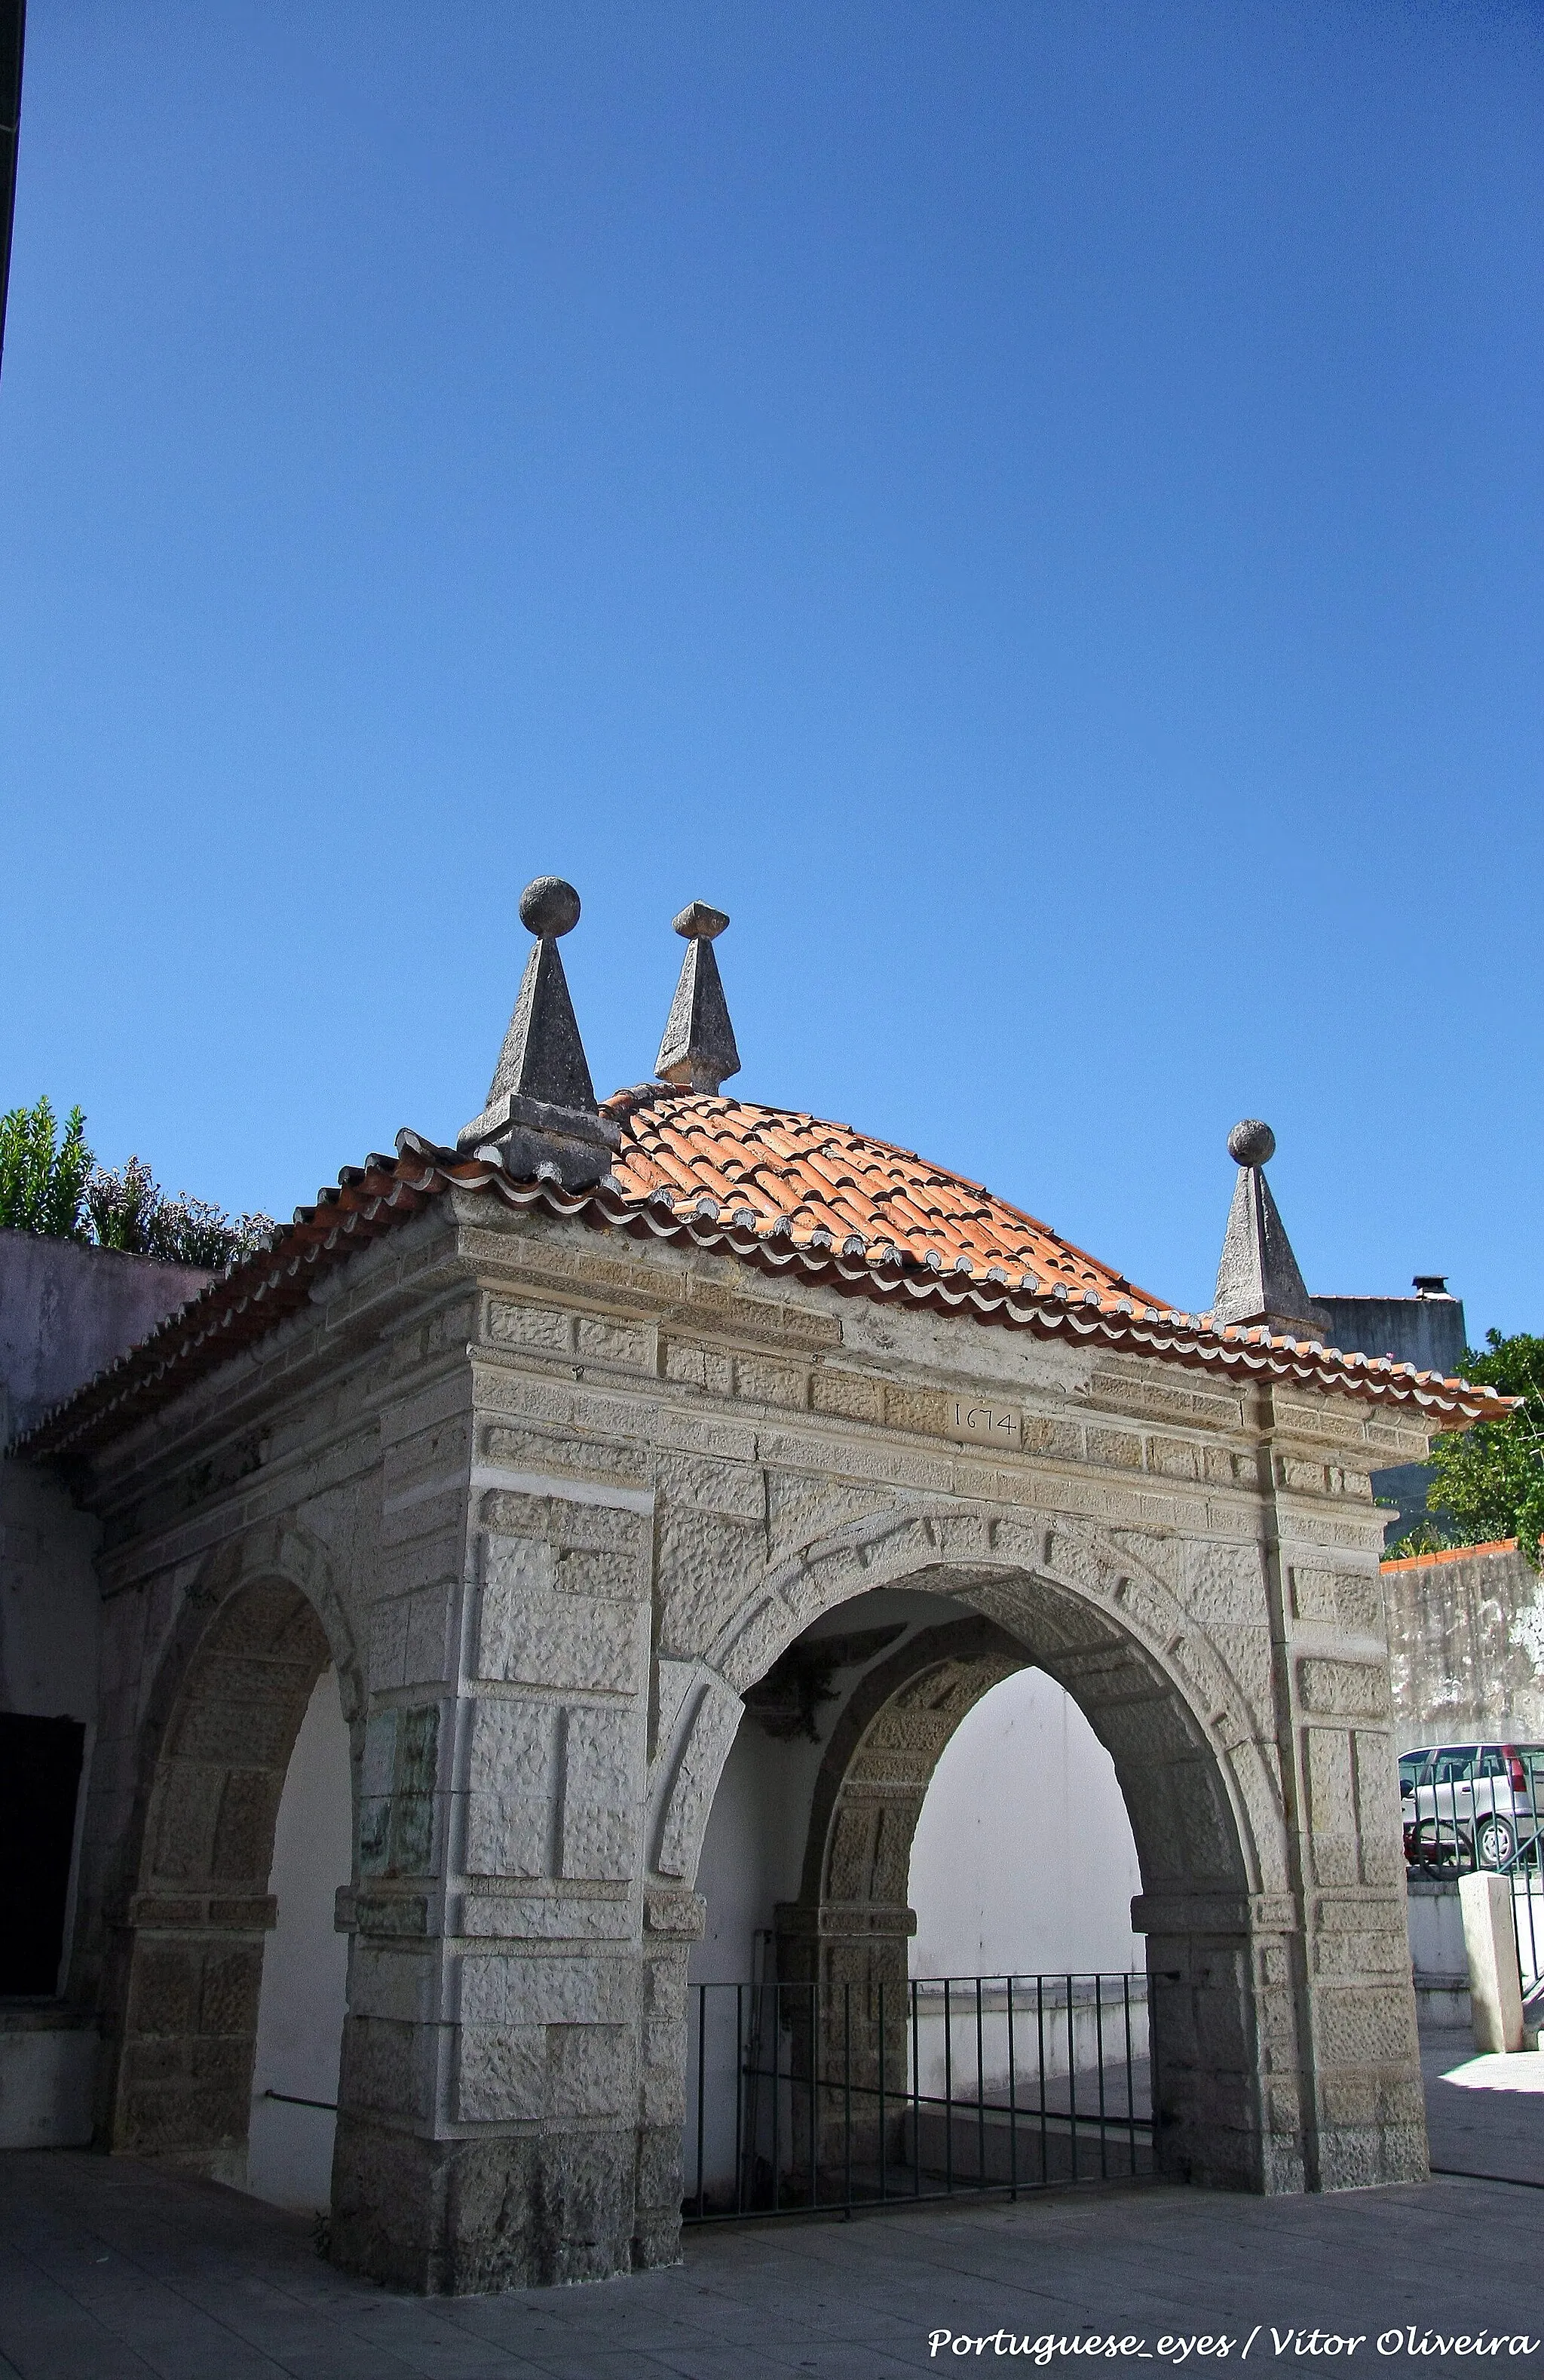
left=247, top=1668, right=354, bottom=2211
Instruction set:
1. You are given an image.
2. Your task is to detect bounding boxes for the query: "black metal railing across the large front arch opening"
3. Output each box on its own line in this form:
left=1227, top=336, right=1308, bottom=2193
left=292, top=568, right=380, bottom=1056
left=683, top=1975, right=1151, bottom=2223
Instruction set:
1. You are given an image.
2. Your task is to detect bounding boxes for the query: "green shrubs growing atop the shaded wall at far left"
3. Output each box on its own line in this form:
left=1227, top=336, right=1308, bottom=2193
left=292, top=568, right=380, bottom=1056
left=0, top=1100, right=274, bottom=1273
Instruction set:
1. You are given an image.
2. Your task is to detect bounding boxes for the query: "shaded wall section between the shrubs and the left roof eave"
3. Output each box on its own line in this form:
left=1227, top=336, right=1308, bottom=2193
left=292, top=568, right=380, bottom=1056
left=0, top=1231, right=212, bottom=1447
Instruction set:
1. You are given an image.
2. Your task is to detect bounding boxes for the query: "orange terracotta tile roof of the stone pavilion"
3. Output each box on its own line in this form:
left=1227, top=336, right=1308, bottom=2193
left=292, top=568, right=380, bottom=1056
left=17, top=1083, right=1513, bottom=1456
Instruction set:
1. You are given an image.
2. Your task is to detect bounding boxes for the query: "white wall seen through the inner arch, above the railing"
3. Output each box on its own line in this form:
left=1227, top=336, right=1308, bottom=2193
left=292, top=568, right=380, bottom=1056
left=911, top=1668, right=1144, bottom=1975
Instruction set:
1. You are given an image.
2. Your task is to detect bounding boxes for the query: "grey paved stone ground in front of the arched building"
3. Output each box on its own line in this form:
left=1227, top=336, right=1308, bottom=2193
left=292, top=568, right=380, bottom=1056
left=0, top=2044, right=1544, bottom=2380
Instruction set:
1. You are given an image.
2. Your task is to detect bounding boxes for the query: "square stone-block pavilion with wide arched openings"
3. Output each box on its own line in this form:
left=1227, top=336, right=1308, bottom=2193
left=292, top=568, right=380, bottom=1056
left=17, top=1133, right=1480, bottom=2290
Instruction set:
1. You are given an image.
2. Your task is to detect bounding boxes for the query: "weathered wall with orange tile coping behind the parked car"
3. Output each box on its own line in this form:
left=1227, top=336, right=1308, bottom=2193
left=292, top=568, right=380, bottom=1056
left=1380, top=1544, right=1544, bottom=1752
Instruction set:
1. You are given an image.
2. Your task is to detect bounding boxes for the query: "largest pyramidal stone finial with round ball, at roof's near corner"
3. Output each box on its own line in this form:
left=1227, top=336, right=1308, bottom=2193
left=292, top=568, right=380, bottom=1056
left=457, top=876, right=621, bottom=1190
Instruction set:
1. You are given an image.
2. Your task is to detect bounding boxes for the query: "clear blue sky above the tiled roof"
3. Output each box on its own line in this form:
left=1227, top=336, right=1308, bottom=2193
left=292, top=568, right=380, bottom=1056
left=0, top=0, right=1544, bottom=1336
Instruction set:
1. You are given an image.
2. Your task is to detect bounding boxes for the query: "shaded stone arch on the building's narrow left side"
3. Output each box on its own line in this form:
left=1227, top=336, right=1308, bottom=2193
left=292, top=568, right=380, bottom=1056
left=107, top=1528, right=362, bottom=2180
